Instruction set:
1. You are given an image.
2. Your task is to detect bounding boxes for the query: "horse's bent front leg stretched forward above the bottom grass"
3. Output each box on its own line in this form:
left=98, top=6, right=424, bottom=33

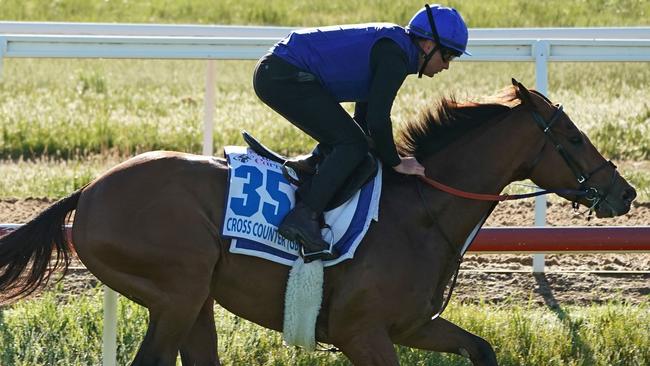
left=396, top=317, right=497, bottom=366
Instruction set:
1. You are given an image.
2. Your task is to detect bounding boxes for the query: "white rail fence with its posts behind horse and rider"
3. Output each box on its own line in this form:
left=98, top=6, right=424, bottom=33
left=0, top=22, right=650, bottom=366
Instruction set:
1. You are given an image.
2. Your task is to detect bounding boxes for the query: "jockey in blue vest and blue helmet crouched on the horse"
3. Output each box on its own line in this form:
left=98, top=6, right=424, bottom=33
left=253, top=5, right=469, bottom=262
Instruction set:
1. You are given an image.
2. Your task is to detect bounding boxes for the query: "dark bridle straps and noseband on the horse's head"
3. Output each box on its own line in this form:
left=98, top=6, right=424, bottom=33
left=531, top=104, right=618, bottom=213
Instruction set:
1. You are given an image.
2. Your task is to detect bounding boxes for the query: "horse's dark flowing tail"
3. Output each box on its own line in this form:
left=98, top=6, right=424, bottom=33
left=0, top=188, right=83, bottom=303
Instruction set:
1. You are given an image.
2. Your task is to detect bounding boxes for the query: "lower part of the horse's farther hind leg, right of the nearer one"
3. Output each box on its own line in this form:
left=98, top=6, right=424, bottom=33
left=180, top=298, right=221, bottom=366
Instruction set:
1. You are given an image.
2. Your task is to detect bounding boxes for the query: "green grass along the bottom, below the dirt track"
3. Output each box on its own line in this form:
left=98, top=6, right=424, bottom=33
left=0, top=289, right=650, bottom=366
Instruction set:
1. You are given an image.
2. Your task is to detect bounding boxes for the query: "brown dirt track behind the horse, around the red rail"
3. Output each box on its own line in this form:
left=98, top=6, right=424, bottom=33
left=0, top=199, right=650, bottom=306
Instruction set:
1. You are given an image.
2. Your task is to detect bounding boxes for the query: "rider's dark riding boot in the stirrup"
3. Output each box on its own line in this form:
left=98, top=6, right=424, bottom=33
left=278, top=202, right=338, bottom=263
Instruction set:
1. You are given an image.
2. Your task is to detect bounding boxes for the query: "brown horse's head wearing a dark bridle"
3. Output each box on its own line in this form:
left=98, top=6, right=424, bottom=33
left=512, top=79, right=636, bottom=217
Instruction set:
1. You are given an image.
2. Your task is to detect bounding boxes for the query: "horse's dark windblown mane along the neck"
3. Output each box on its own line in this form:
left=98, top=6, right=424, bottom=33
left=396, top=86, right=521, bottom=158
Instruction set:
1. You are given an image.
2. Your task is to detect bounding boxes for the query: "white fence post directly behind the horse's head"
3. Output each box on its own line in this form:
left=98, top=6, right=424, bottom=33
left=532, top=40, right=551, bottom=273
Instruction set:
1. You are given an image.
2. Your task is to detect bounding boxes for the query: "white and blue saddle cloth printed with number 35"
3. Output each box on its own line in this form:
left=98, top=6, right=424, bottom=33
left=221, top=146, right=381, bottom=266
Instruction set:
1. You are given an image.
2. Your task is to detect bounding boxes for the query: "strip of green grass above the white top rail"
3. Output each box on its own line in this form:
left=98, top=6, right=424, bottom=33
left=0, top=0, right=650, bottom=27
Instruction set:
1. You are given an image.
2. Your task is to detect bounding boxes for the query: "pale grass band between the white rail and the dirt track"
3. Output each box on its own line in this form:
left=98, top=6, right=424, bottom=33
left=0, top=59, right=650, bottom=200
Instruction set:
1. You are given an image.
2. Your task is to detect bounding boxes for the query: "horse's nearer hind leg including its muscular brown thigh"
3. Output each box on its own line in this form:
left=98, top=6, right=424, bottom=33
left=79, top=222, right=219, bottom=366
